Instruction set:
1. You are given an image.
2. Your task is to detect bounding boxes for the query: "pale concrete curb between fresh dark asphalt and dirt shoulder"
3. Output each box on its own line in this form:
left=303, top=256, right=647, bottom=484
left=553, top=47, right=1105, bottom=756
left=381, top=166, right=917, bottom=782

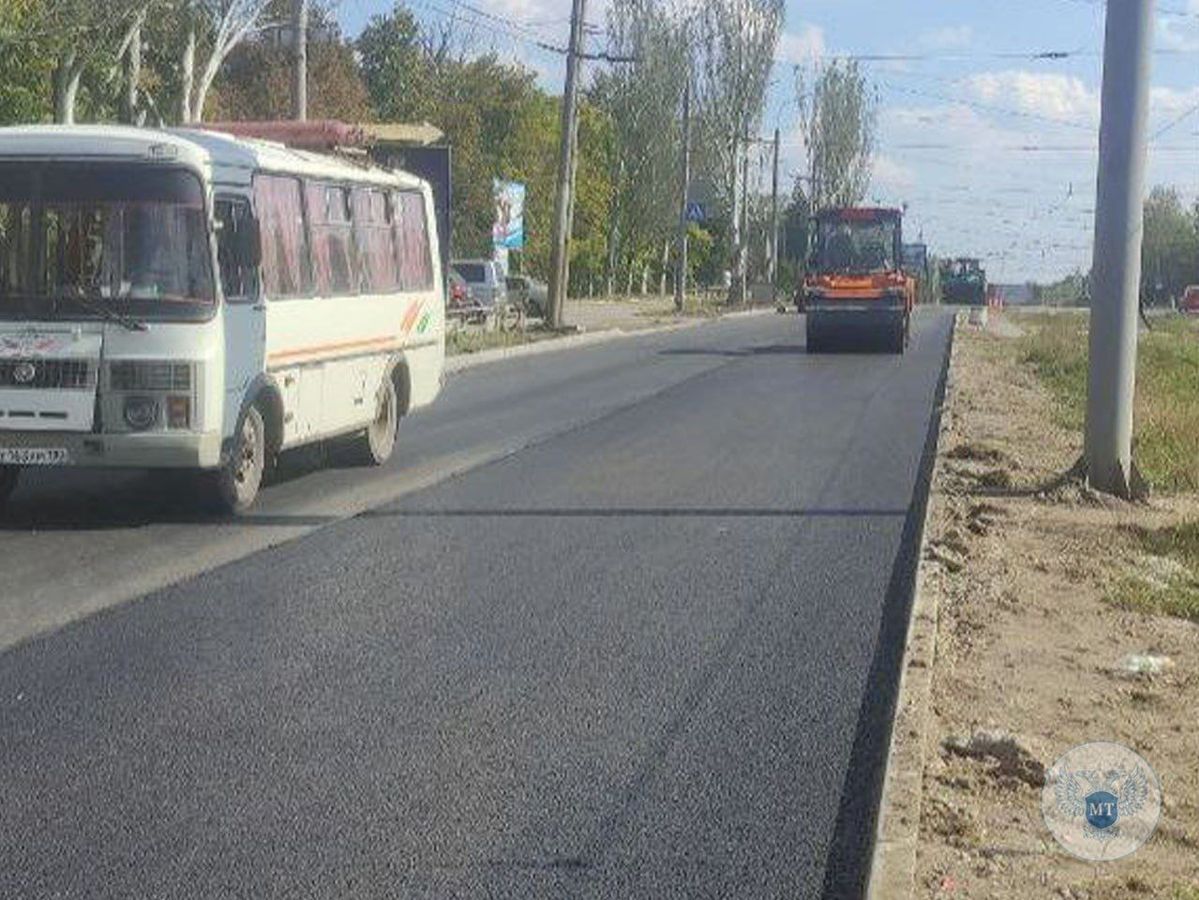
left=866, top=315, right=962, bottom=900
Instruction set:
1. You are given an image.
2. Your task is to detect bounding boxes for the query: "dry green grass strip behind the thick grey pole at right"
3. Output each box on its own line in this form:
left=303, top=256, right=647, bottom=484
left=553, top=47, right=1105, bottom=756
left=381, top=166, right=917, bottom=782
left=1020, top=315, right=1199, bottom=493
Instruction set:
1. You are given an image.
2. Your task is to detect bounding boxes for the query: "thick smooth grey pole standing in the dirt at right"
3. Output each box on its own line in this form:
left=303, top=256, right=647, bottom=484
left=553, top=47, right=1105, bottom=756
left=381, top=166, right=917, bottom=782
left=1084, top=0, right=1153, bottom=497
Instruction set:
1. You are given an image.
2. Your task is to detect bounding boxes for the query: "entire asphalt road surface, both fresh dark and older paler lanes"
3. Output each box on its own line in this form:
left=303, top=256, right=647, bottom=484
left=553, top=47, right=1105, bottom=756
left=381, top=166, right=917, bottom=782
left=0, top=310, right=952, bottom=898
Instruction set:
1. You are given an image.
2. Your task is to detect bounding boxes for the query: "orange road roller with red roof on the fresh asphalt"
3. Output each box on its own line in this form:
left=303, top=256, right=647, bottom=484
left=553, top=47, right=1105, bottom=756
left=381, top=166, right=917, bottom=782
left=803, top=209, right=915, bottom=354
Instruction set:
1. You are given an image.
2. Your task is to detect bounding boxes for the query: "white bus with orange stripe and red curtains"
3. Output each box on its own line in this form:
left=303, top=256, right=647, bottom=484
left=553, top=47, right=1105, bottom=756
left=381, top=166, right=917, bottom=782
left=0, top=126, right=445, bottom=512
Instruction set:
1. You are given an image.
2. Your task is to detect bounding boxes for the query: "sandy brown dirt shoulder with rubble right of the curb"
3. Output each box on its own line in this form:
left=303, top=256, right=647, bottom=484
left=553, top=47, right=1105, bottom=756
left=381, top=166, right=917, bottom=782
left=911, top=318, right=1199, bottom=900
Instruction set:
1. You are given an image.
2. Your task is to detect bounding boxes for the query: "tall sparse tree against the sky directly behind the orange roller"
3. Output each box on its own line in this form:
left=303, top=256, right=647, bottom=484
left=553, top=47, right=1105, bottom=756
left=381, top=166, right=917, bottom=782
left=796, top=60, right=878, bottom=210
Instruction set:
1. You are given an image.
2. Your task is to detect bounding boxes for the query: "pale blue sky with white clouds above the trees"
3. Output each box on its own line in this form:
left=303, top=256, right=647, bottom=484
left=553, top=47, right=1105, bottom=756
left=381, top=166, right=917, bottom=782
left=338, top=0, right=1199, bottom=282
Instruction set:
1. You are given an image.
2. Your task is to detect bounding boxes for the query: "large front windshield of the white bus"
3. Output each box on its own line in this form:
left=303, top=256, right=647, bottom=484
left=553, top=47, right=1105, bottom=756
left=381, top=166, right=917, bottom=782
left=0, top=161, right=216, bottom=320
